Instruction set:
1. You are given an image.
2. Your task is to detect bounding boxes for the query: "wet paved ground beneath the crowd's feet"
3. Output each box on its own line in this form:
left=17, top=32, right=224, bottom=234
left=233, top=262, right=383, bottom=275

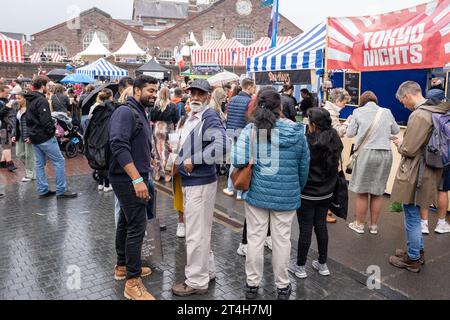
left=0, top=157, right=450, bottom=300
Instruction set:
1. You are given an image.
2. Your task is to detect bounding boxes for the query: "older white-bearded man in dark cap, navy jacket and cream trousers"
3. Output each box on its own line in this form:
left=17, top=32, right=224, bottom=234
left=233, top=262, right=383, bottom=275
left=172, top=80, right=227, bottom=297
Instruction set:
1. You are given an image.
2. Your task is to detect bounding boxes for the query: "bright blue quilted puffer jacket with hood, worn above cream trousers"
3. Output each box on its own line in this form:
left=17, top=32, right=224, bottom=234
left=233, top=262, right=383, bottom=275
left=231, top=119, right=310, bottom=211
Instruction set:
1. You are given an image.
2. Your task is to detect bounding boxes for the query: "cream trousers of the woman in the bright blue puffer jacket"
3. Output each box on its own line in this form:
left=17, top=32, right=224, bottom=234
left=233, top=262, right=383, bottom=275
left=245, top=203, right=297, bottom=289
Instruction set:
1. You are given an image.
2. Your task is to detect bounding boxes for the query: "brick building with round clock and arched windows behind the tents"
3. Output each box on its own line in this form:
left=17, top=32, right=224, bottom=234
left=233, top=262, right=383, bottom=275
left=31, top=0, right=302, bottom=61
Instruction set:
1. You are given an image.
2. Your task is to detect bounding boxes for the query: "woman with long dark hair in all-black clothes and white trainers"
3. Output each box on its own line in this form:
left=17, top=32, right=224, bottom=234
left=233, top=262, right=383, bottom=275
left=295, top=108, right=344, bottom=279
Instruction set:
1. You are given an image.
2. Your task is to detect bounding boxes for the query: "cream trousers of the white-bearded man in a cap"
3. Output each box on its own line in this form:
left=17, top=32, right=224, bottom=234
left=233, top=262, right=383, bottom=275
left=183, top=182, right=217, bottom=290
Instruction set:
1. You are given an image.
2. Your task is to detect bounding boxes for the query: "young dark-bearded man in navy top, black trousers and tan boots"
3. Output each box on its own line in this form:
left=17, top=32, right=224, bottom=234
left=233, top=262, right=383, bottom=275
left=109, top=76, right=158, bottom=300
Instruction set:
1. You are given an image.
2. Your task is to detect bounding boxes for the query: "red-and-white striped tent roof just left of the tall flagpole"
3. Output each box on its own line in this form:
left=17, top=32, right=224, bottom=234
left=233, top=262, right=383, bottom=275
left=192, top=39, right=245, bottom=66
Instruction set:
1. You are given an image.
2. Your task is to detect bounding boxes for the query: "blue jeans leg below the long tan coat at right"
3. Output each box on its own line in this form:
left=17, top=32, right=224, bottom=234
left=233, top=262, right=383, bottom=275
left=403, top=204, right=424, bottom=261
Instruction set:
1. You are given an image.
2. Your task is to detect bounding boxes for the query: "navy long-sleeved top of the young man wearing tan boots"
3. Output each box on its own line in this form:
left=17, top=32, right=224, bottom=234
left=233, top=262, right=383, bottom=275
left=109, top=98, right=152, bottom=183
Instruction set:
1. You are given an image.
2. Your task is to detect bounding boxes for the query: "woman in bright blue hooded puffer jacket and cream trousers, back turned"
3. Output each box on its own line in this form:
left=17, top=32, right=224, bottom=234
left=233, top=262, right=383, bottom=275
left=231, top=89, right=310, bottom=299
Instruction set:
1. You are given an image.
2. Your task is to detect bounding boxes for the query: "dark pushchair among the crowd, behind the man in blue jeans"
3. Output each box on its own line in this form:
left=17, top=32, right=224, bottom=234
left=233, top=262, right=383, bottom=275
left=52, top=112, right=84, bottom=159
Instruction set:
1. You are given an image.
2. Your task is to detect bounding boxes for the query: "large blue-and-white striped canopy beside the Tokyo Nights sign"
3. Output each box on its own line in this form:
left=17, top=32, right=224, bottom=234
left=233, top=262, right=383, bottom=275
left=247, top=23, right=327, bottom=72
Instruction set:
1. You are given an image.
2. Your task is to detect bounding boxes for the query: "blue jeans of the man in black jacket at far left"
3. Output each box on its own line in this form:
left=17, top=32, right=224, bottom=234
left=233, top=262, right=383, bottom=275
left=33, top=138, right=67, bottom=195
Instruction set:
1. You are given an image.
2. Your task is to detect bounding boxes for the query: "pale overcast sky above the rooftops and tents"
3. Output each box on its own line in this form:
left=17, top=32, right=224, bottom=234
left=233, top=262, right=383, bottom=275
left=0, top=0, right=429, bottom=34
